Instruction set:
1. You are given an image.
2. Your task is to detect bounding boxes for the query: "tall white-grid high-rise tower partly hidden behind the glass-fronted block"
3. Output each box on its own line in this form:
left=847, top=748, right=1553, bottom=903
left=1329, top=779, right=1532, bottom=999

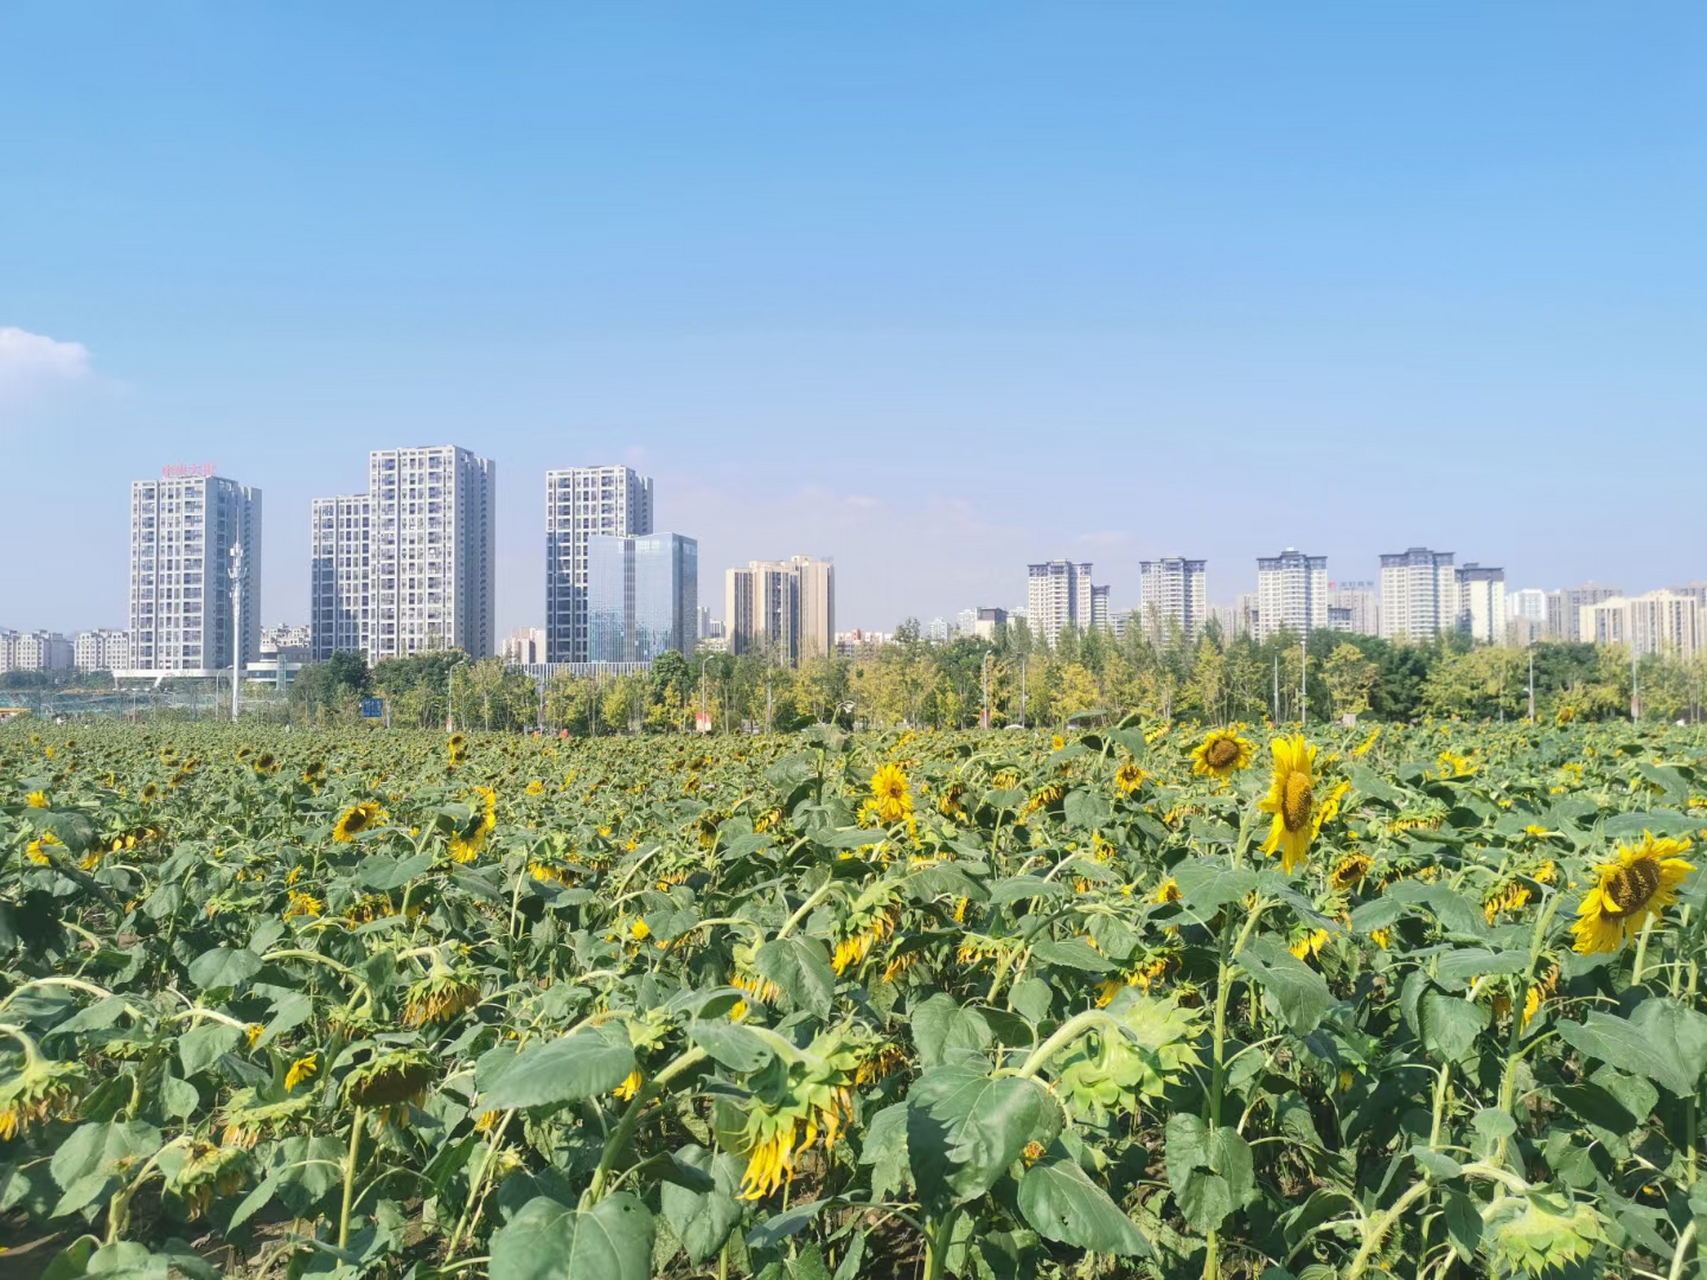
left=545, top=466, right=652, bottom=662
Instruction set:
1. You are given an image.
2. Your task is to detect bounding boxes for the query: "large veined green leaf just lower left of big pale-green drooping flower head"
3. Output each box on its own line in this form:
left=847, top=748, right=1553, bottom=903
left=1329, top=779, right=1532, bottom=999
left=906, top=1067, right=1062, bottom=1201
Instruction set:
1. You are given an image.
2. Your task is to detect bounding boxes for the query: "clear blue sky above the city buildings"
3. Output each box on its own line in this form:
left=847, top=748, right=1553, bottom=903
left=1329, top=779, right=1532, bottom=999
left=0, top=0, right=1707, bottom=630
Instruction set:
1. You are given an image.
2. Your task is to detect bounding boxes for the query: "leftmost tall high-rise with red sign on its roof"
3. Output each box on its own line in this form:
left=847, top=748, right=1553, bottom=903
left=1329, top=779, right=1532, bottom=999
left=116, top=466, right=261, bottom=676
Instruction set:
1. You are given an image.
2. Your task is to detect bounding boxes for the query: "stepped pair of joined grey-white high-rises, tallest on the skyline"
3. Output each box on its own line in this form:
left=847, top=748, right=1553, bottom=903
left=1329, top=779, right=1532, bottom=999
left=309, top=445, right=497, bottom=664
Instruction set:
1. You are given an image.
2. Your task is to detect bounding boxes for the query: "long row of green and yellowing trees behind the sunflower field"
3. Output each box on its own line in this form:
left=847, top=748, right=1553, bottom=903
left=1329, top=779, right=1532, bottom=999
left=292, top=623, right=1707, bottom=736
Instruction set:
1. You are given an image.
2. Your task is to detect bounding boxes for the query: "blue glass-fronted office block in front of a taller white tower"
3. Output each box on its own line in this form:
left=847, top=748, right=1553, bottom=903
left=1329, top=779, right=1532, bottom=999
left=587, top=532, right=700, bottom=662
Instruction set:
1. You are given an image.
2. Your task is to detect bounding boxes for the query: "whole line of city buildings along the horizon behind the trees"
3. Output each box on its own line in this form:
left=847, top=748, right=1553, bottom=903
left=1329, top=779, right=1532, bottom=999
left=10, top=467, right=1707, bottom=684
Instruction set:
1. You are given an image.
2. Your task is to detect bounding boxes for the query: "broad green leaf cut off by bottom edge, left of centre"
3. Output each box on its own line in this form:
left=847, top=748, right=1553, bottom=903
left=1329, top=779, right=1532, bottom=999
left=488, top=1191, right=652, bottom=1280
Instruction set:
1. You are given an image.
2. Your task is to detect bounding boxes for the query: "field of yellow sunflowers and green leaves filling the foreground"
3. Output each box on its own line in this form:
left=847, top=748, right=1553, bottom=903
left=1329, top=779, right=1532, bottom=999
left=0, top=719, right=1707, bottom=1280
